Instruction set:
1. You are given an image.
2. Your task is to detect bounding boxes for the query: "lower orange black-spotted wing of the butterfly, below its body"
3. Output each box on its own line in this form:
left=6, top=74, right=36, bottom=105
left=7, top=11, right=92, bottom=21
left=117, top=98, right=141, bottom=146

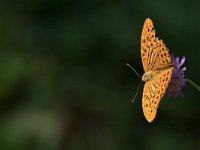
left=142, top=67, right=173, bottom=122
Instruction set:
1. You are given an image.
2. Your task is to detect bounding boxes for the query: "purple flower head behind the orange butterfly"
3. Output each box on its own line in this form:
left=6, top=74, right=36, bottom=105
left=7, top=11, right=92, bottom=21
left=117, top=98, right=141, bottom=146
left=166, top=54, right=186, bottom=97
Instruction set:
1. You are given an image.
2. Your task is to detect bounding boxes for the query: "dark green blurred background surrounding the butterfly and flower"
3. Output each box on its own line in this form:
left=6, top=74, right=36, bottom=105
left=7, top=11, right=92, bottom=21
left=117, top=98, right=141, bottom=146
left=0, top=0, right=200, bottom=150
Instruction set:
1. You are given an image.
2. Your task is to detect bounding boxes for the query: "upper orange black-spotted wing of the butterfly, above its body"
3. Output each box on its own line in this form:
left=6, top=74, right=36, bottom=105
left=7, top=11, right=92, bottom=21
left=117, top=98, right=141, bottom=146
left=141, top=18, right=172, bottom=72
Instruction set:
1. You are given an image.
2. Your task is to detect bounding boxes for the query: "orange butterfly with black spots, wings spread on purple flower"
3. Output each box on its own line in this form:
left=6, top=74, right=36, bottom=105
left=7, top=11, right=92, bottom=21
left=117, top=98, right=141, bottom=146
left=141, top=18, right=174, bottom=122
